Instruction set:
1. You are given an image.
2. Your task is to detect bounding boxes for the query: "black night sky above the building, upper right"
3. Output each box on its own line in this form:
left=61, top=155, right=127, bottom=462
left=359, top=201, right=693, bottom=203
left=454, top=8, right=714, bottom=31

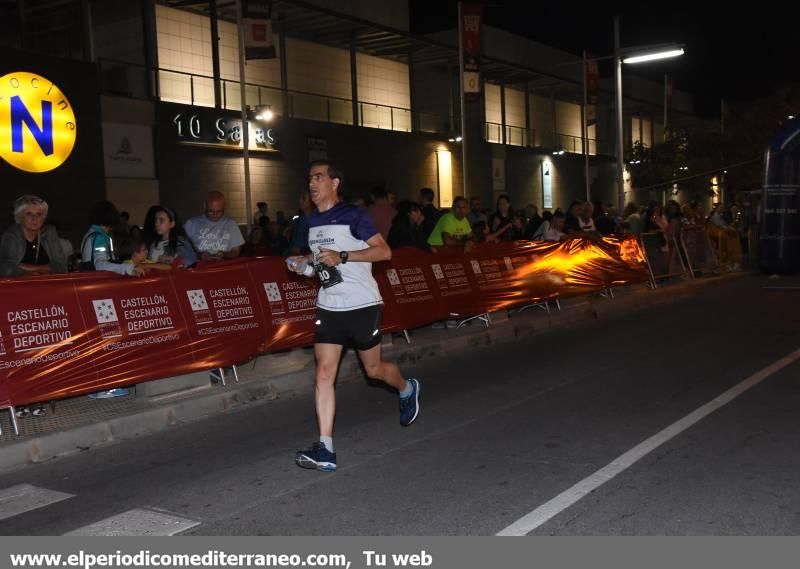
left=409, top=0, right=800, bottom=118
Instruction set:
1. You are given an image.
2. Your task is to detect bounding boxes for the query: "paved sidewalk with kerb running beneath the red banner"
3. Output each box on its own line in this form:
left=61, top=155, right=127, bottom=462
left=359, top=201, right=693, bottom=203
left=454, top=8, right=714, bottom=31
left=0, top=273, right=746, bottom=470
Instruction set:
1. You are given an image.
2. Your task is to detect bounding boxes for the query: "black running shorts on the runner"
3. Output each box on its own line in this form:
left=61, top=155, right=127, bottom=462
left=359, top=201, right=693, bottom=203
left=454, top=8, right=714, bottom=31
left=314, top=304, right=383, bottom=351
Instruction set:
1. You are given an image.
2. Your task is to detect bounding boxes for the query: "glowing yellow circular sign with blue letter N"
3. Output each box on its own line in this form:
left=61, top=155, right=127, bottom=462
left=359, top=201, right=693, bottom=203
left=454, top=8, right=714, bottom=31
left=0, top=71, right=78, bottom=172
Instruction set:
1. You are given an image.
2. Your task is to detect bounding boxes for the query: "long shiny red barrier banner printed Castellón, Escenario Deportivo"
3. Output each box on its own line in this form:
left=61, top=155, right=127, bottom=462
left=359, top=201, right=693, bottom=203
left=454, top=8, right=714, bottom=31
left=0, top=238, right=648, bottom=406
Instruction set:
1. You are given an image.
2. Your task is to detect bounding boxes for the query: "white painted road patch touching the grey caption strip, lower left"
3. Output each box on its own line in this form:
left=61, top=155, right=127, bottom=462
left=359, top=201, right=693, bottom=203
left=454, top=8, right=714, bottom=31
left=64, top=508, right=200, bottom=536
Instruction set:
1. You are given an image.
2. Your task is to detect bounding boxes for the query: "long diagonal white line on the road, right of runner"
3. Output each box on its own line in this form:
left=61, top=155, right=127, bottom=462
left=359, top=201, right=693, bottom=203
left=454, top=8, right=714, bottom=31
left=497, top=349, right=800, bottom=535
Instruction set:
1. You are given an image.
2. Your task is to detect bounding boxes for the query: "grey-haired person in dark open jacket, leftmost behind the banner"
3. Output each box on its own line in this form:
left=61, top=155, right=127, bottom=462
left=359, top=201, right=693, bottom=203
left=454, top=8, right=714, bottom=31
left=0, top=195, right=69, bottom=276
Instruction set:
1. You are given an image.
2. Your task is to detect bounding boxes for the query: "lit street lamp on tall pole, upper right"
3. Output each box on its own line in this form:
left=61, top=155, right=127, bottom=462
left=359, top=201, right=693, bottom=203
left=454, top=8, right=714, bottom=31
left=614, top=16, right=683, bottom=215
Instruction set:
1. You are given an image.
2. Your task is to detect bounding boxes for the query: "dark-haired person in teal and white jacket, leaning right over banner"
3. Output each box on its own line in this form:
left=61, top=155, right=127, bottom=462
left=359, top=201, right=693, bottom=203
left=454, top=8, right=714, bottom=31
left=81, top=201, right=144, bottom=276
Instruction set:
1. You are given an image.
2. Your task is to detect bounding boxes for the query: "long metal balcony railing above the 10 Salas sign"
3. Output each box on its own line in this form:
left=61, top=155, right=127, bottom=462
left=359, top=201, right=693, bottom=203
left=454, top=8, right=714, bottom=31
left=98, top=60, right=447, bottom=133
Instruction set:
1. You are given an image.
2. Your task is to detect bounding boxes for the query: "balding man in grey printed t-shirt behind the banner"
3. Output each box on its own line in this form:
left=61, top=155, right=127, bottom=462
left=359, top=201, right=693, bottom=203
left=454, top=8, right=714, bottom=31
left=184, top=192, right=244, bottom=261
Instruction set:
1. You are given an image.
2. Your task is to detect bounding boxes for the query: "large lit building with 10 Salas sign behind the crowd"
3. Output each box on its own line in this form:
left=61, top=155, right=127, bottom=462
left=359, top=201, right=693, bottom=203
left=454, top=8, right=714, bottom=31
left=3, top=0, right=692, bottom=239
